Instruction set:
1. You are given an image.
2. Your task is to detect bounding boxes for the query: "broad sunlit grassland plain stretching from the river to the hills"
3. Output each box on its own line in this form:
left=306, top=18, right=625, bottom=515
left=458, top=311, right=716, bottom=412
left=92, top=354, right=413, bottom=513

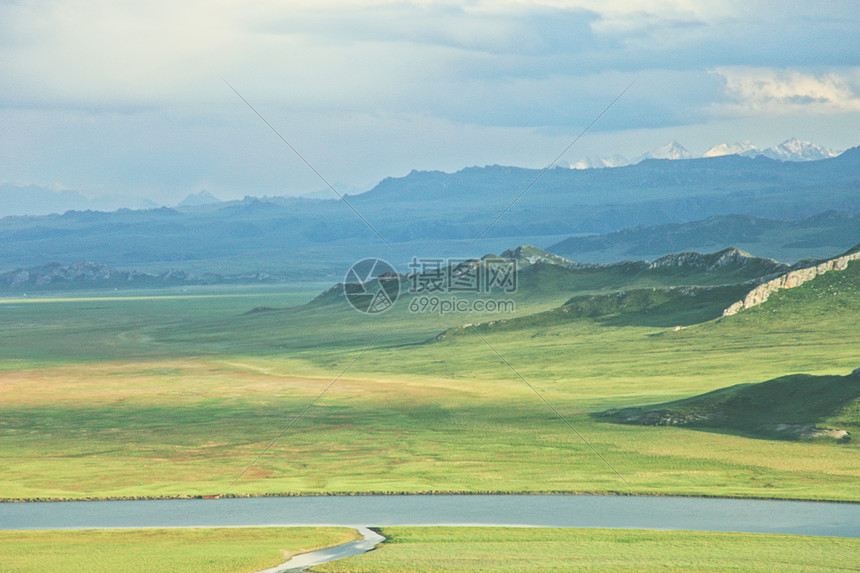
left=0, top=255, right=860, bottom=501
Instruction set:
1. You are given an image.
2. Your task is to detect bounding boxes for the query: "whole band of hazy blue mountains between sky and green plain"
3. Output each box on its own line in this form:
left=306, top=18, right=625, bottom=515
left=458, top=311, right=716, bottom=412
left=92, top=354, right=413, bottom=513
left=0, top=148, right=860, bottom=276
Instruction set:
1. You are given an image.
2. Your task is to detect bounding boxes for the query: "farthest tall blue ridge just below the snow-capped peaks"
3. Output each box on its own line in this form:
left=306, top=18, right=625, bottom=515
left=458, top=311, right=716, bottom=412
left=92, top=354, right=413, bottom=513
left=351, top=148, right=860, bottom=212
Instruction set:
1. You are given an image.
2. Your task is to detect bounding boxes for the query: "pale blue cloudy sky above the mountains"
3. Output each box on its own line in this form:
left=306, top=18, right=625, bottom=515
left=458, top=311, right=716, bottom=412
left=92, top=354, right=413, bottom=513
left=0, top=0, right=860, bottom=204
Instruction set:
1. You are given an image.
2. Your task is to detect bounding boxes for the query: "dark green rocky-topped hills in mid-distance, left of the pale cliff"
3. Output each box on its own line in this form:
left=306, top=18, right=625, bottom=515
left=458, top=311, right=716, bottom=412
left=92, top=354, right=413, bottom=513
left=420, top=245, right=790, bottom=339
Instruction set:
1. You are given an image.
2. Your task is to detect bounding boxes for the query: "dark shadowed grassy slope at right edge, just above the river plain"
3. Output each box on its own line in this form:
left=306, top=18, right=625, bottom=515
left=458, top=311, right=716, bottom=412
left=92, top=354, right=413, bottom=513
left=602, top=374, right=860, bottom=442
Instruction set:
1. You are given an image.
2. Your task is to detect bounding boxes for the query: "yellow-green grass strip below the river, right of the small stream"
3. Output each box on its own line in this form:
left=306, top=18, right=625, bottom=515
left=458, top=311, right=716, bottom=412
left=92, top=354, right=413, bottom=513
left=313, top=527, right=860, bottom=573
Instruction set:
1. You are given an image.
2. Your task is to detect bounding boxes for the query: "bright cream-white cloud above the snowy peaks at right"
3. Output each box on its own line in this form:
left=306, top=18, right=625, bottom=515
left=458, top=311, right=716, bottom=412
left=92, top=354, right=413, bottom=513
left=714, top=67, right=860, bottom=115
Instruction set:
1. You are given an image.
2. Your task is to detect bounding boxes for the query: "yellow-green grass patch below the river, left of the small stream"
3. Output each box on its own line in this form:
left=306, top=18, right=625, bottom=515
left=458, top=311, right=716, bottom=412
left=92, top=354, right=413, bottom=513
left=0, top=527, right=361, bottom=573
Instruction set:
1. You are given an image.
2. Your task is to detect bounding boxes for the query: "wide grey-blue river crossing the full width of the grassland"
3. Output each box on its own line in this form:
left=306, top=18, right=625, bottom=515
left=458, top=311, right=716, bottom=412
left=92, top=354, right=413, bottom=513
left=0, top=495, right=860, bottom=538
